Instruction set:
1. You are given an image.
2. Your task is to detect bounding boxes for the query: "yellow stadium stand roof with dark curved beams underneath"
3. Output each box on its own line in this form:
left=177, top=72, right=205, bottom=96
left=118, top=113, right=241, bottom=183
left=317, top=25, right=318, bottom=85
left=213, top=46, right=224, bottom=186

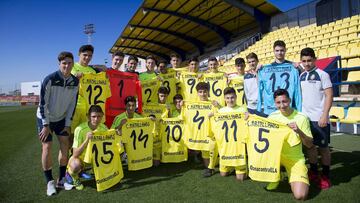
left=110, top=0, right=280, bottom=60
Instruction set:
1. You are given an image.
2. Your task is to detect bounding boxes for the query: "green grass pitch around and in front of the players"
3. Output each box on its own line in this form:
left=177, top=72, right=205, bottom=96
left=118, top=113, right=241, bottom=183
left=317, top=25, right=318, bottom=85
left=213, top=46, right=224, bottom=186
left=0, top=107, right=360, bottom=202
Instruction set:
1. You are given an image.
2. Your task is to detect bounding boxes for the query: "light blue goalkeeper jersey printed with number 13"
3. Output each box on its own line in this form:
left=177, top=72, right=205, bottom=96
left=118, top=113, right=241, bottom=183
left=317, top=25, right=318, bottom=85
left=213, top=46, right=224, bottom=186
left=257, top=60, right=301, bottom=115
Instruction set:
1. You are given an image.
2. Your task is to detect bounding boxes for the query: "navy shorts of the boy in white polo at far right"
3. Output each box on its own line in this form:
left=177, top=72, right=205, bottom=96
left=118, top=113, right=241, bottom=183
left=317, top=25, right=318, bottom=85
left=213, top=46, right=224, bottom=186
left=310, top=121, right=330, bottom=148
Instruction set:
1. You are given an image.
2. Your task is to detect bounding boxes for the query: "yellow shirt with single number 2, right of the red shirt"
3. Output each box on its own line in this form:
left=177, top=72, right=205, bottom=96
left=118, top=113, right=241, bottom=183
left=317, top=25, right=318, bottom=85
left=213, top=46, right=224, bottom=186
left=140, top=79, right=160, bottom=105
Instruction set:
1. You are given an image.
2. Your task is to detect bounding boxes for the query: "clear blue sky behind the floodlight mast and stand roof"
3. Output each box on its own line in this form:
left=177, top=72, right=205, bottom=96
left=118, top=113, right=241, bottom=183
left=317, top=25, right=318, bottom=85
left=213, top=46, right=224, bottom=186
left=0, top=0, right=309, bottom=93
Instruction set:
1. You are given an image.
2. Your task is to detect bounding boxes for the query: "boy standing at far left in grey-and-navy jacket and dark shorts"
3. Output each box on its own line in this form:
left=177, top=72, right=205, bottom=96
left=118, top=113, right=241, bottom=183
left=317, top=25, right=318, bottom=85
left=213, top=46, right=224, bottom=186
left=36, top=52, right=79, bottom=196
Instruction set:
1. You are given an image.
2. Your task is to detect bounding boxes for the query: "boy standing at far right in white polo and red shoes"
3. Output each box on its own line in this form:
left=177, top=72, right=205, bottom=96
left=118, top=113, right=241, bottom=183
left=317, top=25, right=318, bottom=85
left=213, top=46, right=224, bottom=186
left=300, top=48, right=333, bottom=189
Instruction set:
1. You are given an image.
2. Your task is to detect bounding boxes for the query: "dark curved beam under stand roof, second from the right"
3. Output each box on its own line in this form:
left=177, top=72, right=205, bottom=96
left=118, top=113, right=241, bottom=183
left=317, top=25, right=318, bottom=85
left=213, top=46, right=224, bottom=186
left=143, top=7, right=231, bottom=46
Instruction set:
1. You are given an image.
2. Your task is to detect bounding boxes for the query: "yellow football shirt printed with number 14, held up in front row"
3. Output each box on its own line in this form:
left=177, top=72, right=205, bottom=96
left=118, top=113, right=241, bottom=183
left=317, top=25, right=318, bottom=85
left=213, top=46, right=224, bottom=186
left=121, top=118, right=155, bottom=171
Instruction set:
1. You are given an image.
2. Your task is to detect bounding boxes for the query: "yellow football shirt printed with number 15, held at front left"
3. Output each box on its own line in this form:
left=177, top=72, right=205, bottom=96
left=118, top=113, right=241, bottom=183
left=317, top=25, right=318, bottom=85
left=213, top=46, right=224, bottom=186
left=84, top=129, right=124, bottom=192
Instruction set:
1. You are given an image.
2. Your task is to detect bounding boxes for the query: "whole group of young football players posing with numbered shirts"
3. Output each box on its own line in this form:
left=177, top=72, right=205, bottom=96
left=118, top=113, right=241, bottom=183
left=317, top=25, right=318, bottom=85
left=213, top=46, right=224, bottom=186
left=37, top=40, right=333, bottom=200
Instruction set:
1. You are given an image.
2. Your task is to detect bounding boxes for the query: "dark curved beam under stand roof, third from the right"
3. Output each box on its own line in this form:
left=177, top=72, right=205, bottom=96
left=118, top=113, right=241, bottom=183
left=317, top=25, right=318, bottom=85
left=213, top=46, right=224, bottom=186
left=129, top=24, right=205, bottom=55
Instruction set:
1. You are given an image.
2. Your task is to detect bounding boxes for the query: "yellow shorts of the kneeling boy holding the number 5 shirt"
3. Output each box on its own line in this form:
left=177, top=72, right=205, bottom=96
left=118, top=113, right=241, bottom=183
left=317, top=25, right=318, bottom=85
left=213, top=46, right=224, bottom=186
left=280, top=157, right=309, bottom=185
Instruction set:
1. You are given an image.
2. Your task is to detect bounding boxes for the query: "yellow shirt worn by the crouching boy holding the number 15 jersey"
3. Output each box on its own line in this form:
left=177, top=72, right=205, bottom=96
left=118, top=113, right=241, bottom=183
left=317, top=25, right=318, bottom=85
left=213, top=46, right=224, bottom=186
left=72, top=122, right=108, bottom=160
